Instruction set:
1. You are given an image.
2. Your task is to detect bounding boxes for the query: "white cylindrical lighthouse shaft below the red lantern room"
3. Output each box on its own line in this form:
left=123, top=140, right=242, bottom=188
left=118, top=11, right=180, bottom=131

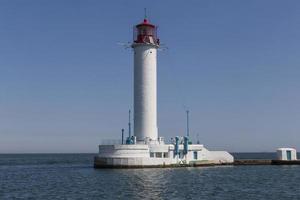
left=132, top=44, right=158, bottom=141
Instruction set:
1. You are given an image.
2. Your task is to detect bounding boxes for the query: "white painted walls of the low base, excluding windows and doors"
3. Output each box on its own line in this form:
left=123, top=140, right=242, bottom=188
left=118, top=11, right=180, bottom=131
left=97, top=144, right=233, bottom=166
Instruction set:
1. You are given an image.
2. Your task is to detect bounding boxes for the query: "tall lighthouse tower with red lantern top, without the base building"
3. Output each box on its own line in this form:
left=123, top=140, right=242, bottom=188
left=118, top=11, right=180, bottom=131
left=131, top=18, right=159, bottom=142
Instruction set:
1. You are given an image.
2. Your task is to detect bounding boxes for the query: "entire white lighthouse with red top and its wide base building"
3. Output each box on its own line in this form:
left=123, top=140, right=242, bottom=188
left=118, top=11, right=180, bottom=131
left=94, top=19, right=234, bottom=167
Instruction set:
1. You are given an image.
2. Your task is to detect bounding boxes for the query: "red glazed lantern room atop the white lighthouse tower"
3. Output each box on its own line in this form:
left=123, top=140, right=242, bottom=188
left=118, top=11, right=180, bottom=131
left=133, top=18, right=159, bottom=45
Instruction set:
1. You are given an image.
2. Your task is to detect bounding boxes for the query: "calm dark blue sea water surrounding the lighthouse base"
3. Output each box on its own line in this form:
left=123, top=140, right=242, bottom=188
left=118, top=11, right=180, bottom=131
left=0, top=153, right=300, bottom=200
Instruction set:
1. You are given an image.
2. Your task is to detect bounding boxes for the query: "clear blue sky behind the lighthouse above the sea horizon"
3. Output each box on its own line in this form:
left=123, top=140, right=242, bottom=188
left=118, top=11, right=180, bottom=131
left=0, top=0, right=300, bottom=153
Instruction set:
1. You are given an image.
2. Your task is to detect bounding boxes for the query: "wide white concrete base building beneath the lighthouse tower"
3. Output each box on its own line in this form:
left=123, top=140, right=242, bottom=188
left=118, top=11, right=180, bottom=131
left=94, top=143, right=234, bottom=168
